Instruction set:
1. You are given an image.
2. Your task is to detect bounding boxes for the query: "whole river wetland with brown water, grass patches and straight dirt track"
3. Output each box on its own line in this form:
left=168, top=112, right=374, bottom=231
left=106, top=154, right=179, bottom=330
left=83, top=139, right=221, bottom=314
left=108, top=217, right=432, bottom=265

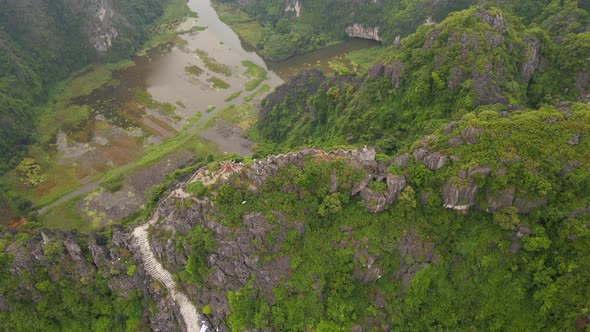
left=2, top=0, right=382, bottom=231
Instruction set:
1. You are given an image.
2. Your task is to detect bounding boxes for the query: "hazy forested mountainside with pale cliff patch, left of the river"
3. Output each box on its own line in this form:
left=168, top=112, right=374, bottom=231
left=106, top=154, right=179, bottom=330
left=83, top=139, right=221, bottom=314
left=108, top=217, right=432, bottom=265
left=0, top=0, right=167, bottom=171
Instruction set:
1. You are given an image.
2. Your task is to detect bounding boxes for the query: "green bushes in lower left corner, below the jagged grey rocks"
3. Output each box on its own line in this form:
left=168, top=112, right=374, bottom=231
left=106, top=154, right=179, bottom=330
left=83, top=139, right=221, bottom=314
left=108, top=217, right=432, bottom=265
left=0, top=226, right=147, bottom=331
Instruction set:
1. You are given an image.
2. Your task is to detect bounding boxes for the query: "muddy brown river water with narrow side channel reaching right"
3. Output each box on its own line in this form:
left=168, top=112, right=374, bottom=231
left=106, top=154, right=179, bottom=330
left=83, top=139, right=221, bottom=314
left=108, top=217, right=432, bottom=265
left=2, top=0, right=378, bottom=226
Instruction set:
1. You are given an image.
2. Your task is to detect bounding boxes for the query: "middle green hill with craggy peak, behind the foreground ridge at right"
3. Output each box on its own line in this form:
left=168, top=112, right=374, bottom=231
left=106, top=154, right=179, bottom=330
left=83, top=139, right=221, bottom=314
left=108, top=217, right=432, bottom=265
left=258, top=3, right=590, bottom=153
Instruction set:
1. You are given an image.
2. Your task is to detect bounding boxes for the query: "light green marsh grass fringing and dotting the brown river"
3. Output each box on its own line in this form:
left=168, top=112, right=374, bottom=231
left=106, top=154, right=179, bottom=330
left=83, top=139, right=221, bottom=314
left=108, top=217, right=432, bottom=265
left=0, top=0, right=378, bottom=231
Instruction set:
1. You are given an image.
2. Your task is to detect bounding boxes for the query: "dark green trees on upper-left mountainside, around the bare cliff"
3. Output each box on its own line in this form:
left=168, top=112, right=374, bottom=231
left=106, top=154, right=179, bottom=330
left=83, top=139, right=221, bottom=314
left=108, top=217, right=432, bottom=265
left=0, top=0, right=186, bottom=173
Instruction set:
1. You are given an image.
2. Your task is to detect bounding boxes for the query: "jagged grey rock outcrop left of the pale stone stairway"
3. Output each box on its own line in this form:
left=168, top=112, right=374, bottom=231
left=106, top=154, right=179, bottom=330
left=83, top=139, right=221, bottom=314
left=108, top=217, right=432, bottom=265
left=0, top=226, right=179, bottom=331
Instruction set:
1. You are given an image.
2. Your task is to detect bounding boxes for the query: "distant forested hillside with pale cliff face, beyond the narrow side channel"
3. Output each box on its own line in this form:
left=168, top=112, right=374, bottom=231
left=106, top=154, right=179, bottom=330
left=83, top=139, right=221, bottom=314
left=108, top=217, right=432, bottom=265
left=218, top=0, right=572, bottom=60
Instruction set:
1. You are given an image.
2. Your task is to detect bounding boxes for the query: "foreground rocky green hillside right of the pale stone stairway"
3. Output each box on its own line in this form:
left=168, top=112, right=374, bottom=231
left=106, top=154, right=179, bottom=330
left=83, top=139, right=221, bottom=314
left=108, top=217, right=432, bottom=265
left=138, top=103, right=590, bottom=331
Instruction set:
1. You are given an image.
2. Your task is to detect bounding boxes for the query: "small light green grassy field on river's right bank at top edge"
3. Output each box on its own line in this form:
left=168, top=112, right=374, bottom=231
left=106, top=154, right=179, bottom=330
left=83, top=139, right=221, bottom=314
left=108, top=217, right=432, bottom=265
left=212, top=1, right=262, bottom=48
